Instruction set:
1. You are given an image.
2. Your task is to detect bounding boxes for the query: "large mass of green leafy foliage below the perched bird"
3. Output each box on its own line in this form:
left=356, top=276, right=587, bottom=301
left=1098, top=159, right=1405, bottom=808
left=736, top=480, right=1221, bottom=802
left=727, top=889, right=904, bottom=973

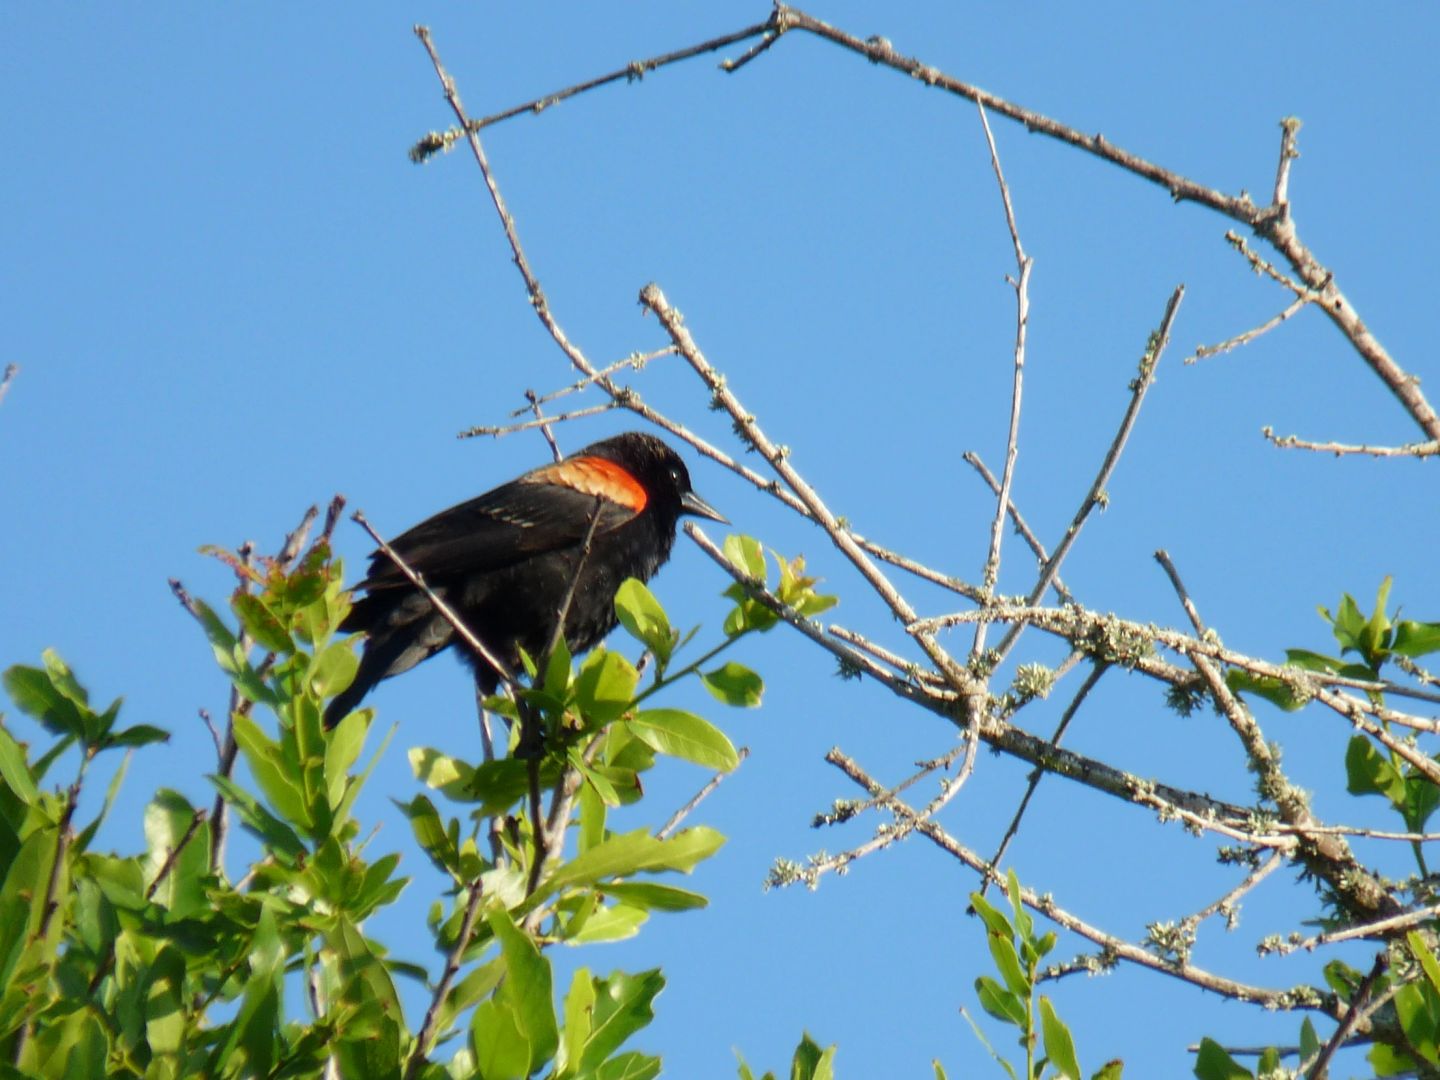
left=0, top=529, right=832, bottom=1080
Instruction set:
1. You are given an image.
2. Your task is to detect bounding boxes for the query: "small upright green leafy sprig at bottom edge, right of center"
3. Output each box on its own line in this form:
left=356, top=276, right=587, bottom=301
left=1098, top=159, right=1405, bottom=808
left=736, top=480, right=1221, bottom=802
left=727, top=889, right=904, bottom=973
left=961, top=870, right=1123, bottom=1080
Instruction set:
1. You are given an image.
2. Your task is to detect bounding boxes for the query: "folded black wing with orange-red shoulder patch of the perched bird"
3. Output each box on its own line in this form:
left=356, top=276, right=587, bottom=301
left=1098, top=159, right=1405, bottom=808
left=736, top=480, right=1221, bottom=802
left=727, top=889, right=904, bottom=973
left=361, top=458, right=645, bottom=592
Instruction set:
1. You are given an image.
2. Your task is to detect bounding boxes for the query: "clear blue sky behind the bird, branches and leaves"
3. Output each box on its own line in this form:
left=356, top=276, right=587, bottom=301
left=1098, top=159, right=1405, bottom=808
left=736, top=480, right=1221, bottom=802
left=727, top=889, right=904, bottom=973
left=0, top=0, right=1440, bottom=1077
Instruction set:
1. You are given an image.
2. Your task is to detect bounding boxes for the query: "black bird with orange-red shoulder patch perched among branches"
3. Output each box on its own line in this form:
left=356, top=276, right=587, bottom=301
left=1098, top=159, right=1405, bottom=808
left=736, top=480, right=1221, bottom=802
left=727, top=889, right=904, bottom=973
left=325, top=432, right=726, bottom=727
